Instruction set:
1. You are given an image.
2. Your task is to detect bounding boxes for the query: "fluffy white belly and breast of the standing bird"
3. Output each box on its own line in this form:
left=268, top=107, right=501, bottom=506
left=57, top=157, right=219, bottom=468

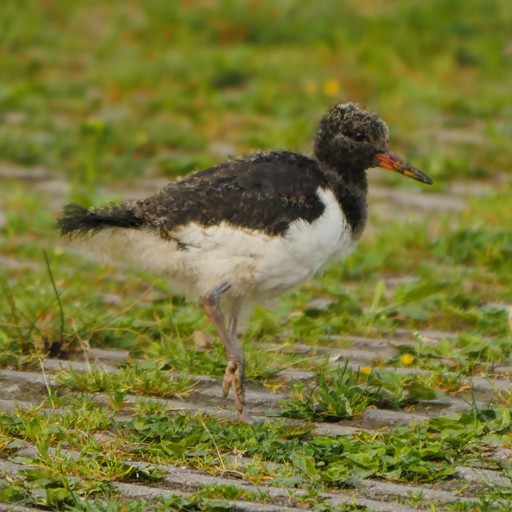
left=86, top=189, right=352, bottom=302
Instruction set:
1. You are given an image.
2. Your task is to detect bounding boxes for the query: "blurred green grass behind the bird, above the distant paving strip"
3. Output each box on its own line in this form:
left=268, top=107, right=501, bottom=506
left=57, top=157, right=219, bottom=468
left=0, top=0, right=512, bottom=192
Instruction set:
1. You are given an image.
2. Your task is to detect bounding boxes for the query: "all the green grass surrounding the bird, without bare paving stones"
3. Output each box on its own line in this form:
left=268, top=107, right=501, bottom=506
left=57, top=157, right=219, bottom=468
left=0, top=0, right=512, bottom=511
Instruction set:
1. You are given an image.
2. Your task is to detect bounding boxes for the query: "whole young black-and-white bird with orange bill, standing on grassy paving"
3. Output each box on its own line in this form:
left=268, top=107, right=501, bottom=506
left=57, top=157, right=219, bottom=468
left=57, top=103, right=432, bottom=423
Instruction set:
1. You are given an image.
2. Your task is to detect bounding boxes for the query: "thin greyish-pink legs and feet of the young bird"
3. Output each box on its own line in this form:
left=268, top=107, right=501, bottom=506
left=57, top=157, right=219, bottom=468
left=203, top=284, right=254, bottom=423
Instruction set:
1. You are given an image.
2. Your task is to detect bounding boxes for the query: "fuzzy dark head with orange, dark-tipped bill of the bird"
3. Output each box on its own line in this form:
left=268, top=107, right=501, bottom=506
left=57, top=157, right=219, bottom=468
left=315, top=103, right=432, bottom=185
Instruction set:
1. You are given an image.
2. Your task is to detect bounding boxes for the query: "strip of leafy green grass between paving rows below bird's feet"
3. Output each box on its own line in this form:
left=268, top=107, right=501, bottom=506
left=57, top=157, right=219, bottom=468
left=0, top=408, right=511, bottom=506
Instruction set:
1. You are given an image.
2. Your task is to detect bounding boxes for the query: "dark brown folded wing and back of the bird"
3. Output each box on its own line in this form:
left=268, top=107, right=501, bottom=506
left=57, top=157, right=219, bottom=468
left=133, top=151, right=324, bottom=235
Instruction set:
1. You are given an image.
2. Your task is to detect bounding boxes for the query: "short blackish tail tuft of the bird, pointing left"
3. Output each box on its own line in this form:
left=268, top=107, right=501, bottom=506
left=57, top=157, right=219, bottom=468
left=57, top=204, right=144, bottom=238
